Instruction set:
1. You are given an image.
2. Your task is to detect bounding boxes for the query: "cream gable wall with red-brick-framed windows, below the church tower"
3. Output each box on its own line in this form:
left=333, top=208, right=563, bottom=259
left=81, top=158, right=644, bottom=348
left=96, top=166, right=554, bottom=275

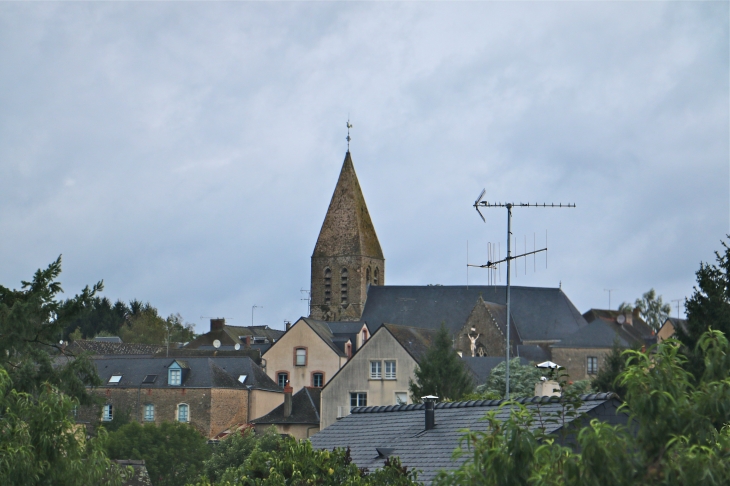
left=257, top=319, right=347, bottom=394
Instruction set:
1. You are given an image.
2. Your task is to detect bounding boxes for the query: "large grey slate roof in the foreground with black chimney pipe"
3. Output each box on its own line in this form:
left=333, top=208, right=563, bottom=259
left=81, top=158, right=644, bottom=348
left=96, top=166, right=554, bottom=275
left=309, top=393, right=627, bottom=484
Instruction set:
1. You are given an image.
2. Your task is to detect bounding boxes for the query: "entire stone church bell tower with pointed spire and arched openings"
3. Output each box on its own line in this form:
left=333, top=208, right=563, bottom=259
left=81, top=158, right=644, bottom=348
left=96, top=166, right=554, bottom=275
left=309, top=150, right=385, bottom=321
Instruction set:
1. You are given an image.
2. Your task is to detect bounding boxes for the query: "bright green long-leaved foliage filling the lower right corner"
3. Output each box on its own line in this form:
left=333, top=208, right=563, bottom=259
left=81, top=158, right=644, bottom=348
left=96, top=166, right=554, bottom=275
left=436, top=331, right=730, bottom=486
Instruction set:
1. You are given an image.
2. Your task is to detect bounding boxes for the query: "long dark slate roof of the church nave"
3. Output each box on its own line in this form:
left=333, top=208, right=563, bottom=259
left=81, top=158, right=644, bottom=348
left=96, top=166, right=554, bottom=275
left=362, top=285, right=586, bottom=341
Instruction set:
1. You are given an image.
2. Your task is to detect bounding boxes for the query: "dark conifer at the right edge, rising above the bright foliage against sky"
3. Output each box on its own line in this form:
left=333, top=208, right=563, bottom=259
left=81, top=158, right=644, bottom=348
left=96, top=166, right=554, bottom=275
left=675, top=235, right=730, bottom=378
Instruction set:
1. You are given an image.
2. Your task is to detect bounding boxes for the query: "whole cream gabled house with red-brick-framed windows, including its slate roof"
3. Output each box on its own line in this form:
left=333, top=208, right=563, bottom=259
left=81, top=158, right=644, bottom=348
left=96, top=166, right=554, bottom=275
left=262, top=317, right=370, bottom=393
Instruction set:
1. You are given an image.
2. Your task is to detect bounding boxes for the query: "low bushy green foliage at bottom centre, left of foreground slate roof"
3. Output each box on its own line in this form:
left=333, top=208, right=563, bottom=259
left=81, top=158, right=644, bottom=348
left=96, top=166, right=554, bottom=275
left=198, top=437, right=419, bottom=486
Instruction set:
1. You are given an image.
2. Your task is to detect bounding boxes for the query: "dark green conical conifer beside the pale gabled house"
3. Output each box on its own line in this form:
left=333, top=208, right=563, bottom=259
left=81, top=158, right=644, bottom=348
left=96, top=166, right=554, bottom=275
left=409, top=323, right=474, bottom=403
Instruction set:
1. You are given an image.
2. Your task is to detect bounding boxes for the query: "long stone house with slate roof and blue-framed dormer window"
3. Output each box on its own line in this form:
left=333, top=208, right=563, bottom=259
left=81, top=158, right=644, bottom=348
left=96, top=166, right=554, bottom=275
left=77, top=356, right=284, bottom=437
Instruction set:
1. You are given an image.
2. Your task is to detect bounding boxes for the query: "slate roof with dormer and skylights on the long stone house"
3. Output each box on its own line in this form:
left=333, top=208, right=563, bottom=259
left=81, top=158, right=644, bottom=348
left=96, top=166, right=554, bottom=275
left=93, top=356, right=283, bottom=392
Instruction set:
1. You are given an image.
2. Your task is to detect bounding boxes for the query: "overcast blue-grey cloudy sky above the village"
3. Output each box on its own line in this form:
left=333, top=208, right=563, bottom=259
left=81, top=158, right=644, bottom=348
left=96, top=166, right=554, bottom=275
left=0, top=1, right=730, bottom=332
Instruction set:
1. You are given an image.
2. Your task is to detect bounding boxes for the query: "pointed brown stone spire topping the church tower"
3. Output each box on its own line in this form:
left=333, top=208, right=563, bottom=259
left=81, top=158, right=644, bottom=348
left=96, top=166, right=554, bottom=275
left=312, top=152, right=383, bottom=259
